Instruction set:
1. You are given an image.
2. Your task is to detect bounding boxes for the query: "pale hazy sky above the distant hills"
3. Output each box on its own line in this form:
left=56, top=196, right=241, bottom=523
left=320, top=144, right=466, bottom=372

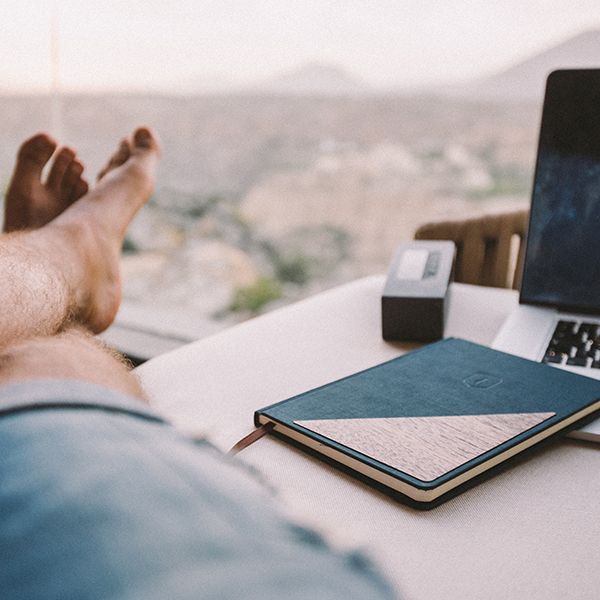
left=0, top=0, right=600, bottom=93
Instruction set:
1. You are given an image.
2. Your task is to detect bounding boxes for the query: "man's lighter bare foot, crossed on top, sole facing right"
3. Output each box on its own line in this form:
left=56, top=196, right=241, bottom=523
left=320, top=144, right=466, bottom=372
left=48, top=127, right=159, bottom=333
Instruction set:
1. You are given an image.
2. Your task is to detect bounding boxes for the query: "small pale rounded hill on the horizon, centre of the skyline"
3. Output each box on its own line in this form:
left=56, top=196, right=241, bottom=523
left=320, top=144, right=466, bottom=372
left=254, top=63, right=370, bottom=96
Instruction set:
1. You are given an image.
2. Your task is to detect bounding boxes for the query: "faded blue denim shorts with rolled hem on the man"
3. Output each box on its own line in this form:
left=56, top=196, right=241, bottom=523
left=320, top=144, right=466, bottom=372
left=0, top=380, right=393, bottom=600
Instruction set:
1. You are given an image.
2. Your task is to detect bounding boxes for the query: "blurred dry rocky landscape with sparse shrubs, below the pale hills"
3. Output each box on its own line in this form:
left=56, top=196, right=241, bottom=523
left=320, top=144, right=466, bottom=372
left=0, top=95, right=540, bottom=325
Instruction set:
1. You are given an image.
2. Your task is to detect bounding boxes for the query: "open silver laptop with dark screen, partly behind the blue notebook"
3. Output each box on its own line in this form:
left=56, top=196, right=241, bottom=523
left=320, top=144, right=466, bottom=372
left=492, top=69, right=600, bottom=442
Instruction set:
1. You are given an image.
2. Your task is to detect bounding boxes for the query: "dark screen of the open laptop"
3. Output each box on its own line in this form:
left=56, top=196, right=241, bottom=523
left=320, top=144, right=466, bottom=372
left=521, top=69, right=600, bottom=312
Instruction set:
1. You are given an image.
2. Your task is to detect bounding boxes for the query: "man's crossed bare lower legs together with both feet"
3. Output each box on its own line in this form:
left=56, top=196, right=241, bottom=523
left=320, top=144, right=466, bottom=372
left=0, top=129, right=158, bottom=398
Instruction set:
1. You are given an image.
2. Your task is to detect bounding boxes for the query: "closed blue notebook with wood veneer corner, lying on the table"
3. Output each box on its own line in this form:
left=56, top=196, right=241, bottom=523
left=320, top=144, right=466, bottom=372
left=255, top=338, right=600, bottom=507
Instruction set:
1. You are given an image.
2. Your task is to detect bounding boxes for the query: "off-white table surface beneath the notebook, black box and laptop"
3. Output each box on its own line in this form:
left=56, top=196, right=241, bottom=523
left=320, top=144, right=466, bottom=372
left=137, top=276, right=600, bottom=599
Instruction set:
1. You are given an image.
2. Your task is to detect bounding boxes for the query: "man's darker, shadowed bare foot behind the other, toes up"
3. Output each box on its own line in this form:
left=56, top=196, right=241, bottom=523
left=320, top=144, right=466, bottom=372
left=4, top=133, right=88, bottom=233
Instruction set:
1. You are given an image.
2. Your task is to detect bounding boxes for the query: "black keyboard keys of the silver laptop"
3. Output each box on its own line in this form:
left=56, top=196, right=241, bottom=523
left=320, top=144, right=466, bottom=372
left=542, top=321, right=600, bottom=369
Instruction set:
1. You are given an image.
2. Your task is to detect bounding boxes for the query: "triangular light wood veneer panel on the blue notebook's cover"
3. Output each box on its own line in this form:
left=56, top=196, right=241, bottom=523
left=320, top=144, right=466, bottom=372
left=295, top=412, right=555, bottom=481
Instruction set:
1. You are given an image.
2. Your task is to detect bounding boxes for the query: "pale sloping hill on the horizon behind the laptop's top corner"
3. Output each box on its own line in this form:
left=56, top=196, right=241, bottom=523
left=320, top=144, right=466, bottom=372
left=442, top=30, right=600, bottom=102
